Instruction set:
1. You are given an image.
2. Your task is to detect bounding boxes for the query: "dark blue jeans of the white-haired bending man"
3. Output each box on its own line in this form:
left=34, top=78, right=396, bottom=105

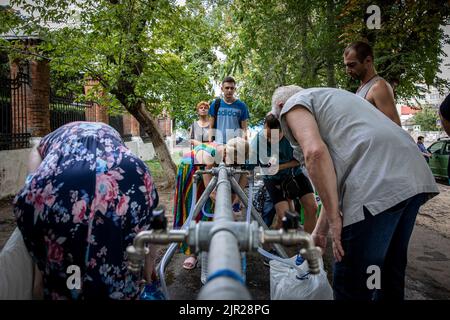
left=333, top=194, right=427, bottom=300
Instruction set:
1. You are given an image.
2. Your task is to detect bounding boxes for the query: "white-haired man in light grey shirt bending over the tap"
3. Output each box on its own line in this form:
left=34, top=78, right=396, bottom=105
left=272, top=86, right=439, bottom=300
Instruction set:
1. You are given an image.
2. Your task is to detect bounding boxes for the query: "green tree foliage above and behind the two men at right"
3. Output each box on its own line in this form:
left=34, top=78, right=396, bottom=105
left=211, top=0, right=450, bottom=122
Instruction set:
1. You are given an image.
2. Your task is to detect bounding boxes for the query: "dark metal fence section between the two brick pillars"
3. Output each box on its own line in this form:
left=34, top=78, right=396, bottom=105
left=50, top=94, right=93, bottom=131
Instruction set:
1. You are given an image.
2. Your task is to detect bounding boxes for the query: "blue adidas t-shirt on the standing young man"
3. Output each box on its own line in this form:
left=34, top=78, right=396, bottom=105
left=209, top=99, right=249, bottom=143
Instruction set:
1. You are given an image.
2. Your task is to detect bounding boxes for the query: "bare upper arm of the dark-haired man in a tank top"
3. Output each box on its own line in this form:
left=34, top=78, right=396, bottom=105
left=367, top=80, right=402, bottom=126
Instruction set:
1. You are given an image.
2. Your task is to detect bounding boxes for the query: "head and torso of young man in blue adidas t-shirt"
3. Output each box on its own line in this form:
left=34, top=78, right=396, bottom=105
left=209, top=77, right=249, bottom=144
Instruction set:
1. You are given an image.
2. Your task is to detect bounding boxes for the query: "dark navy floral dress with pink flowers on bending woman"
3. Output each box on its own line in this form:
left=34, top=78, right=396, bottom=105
left=14, top=122, right=158, bottom=299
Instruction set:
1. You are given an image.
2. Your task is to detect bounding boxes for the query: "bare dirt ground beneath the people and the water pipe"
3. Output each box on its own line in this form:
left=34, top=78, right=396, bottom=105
left=0, top=179, right=450, bottom=300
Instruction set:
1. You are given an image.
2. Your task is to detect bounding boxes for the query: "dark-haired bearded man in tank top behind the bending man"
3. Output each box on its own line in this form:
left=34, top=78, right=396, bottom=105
left=344, top=41, right=401, bottom=126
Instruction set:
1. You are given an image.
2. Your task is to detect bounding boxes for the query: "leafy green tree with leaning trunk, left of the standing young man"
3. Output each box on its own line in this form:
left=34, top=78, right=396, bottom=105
left=4, top=0, right=225, bottom=182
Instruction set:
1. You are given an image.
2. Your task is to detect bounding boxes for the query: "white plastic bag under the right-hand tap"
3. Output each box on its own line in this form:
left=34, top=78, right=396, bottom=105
left=270, top=256, right=333, bottom=300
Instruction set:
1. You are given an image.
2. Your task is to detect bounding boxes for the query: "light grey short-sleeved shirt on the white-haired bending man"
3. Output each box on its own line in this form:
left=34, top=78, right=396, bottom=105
left=280, top=88, right=439, bottom=226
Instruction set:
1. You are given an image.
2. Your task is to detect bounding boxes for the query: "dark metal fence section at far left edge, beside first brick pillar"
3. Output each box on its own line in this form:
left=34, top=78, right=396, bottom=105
left=0, top=69, right=31, bottom=150
